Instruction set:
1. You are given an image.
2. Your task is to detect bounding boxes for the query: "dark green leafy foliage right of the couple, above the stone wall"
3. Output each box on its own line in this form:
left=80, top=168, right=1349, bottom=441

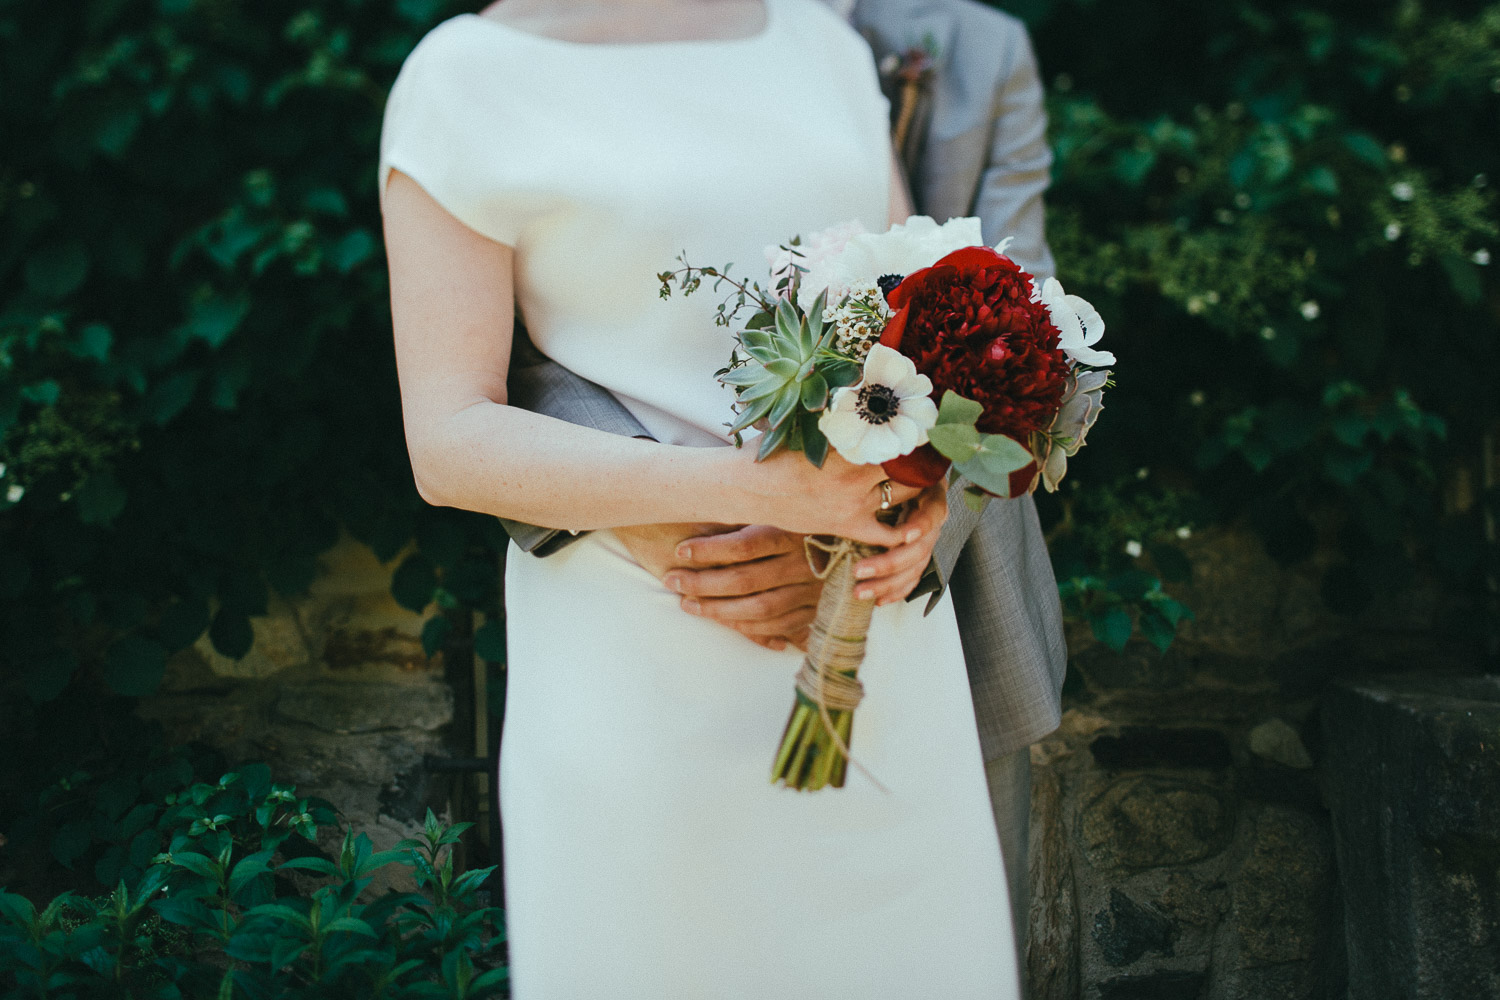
left=1020, top=0, right=1500, bottom=646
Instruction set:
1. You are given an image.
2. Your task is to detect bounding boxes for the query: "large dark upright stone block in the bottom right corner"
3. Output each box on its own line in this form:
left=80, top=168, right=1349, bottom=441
left=1323, top=673, right=1500, bottom=1000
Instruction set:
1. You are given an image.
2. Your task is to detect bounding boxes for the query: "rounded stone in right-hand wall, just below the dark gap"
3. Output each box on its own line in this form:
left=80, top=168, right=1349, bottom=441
left=1080, top=774, right=1235, bottom=870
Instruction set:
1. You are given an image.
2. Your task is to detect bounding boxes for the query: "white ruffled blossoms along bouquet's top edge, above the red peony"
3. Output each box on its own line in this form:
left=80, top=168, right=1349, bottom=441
left=798, top=216, right=984, bottom=309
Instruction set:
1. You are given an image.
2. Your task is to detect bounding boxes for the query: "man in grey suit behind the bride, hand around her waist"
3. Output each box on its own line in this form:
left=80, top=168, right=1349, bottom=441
left=506, top=0, right=1067, bottom=964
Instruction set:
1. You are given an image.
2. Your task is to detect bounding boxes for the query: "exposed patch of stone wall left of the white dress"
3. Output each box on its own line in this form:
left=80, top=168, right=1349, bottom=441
left=140, top=538, right=453, bottom=869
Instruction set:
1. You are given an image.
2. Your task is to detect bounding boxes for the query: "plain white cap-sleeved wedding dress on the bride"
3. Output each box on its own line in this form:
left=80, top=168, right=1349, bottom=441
left=380, top=0, right=1019, bottom=1000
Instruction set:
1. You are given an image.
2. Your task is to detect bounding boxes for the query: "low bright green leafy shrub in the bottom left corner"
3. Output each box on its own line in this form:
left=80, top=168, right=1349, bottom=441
left=0, top=765, right=507, bottom=1000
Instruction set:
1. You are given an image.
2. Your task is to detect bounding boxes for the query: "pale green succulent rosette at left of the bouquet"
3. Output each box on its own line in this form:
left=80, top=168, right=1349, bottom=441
left=720, top=292, right=860, bottom=466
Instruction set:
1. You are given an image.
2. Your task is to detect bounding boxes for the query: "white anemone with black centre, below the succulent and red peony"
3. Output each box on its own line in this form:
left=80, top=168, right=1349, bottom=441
left=818, top=343, right=938, bottom=465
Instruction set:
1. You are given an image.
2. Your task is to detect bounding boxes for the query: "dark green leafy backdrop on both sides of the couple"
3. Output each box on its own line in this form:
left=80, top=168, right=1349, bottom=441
left=0, top=0, right=1500, bottom=702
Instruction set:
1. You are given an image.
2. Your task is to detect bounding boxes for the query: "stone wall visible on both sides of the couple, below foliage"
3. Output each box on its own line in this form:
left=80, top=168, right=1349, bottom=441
left=141, top=532, right=1463, bottom=1000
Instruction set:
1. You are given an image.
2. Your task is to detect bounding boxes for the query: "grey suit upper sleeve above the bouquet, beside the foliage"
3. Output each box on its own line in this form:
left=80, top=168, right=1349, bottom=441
left=974, top=22, right=1058, bottom=279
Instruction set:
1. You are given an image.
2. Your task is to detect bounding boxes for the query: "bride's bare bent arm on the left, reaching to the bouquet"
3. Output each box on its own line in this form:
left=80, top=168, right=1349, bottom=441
left=384, top=171, right=915, bottom=546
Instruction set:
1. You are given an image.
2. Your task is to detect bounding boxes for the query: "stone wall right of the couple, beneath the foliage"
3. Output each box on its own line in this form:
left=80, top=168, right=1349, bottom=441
left=1028, top=531, right=1466, bottom=1000
